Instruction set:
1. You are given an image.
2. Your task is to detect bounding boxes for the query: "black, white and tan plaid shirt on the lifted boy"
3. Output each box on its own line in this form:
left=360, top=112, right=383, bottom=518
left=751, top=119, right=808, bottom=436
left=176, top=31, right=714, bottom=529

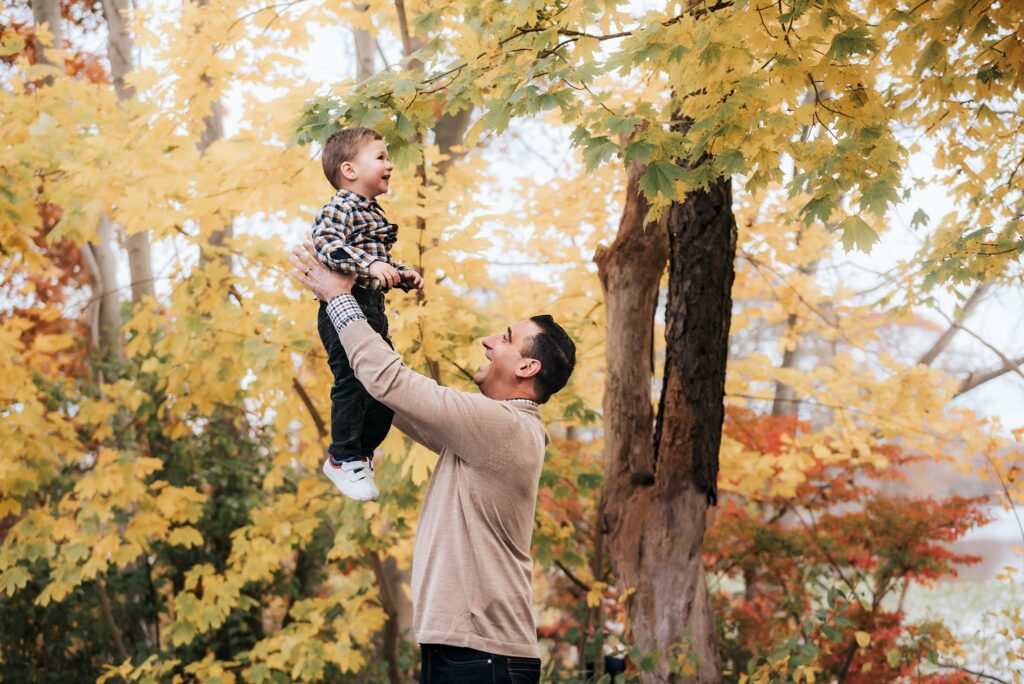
left=312, top=189, right=406, bottom=291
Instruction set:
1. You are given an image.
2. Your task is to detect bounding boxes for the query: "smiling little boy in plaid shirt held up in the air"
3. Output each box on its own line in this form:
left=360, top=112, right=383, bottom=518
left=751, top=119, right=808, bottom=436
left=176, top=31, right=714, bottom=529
left=312, top=128, right=423, bottom=501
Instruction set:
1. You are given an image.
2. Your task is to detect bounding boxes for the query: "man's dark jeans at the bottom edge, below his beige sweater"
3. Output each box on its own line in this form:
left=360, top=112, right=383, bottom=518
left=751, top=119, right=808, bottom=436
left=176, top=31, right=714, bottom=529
left=420, top=644, right=541, bottom=684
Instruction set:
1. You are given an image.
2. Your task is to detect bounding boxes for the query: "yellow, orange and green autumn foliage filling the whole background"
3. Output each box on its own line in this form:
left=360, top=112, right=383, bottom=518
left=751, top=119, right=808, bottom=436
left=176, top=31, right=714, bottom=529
left=6, top=0, right=1024, bottom=684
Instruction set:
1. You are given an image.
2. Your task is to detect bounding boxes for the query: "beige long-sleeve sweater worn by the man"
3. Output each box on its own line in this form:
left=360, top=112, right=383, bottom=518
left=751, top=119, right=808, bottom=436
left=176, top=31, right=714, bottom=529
left=340, top=320, right=548, bottom=657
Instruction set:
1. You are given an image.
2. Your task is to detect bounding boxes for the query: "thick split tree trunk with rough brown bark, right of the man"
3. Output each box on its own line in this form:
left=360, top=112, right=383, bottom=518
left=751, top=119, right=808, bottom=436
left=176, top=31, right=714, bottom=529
left=595, top=166, right=736, bottom=682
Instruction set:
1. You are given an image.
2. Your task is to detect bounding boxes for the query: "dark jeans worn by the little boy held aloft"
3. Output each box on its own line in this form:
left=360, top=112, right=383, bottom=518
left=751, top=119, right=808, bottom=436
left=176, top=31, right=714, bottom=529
left=316, top=286, right=394, bottom=462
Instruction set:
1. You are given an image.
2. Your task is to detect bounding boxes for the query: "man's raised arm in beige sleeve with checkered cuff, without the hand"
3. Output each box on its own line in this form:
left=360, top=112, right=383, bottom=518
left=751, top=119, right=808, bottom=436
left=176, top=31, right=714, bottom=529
left=328, top=295, right=519, bottom=469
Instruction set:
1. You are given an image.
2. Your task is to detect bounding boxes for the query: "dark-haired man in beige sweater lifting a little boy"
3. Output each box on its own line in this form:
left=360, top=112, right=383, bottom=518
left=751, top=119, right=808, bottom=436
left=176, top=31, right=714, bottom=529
left=292, top=245, right=575, bottom=684
